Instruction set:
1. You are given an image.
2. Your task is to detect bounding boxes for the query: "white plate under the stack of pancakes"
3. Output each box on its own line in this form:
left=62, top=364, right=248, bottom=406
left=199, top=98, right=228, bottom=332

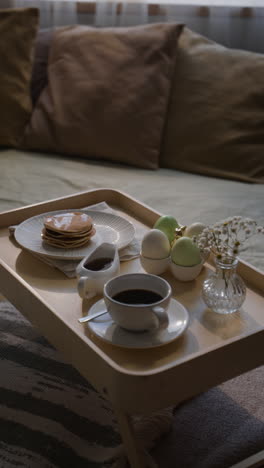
left=14, top=209, right=135, bottom=260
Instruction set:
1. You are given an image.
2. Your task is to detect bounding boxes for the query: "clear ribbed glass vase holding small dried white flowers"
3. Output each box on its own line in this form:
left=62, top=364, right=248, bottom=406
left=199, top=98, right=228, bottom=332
left=202, top=257, right=246, bottom=314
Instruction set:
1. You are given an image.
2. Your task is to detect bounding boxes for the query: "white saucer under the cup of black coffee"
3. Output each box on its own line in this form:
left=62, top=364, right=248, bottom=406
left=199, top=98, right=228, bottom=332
left=87, top=299, right=189, bottom=348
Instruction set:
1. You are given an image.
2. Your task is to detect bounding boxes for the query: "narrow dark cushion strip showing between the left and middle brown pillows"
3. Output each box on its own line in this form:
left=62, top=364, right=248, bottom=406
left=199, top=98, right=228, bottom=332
left=31, top=29, right=54, bottom=106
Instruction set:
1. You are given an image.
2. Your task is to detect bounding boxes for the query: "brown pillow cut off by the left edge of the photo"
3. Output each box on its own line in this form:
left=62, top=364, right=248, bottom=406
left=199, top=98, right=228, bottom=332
left=0, top=8, right=39, bottom=146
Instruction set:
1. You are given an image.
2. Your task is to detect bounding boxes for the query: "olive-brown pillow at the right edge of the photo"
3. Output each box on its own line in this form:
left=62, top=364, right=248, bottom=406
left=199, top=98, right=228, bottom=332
left=160, top=28, right=264, bottom=183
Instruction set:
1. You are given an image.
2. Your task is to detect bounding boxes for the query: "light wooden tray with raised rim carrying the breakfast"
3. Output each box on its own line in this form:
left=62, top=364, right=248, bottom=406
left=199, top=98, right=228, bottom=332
left=0, top=189, right=264, bottom=413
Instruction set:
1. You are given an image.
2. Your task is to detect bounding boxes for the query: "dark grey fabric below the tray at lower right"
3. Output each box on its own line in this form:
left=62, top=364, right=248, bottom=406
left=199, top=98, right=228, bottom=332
left=155, top=366, right=264, bottom=468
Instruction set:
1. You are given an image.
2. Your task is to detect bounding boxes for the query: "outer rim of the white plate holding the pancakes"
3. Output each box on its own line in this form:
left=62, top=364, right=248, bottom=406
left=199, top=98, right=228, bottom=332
left=14, top=208, right=135, bottom=260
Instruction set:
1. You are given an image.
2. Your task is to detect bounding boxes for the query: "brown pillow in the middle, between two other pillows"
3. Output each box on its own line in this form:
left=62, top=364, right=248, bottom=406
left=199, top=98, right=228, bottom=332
left=24, top=24, right=182, bottom=168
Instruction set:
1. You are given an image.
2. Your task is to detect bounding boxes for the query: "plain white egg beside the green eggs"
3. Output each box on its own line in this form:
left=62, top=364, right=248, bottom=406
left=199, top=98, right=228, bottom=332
left=141, top=229, right=170, bottom=259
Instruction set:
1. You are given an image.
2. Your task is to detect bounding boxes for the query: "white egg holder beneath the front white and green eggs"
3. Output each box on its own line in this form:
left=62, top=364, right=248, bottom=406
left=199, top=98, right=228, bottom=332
left=140, top=252, right=208, bottom=281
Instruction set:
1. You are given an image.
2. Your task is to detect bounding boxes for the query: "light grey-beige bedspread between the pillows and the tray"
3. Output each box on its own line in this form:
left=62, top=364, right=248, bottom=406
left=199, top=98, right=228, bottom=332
left=0, top=150, right=264, bottom=271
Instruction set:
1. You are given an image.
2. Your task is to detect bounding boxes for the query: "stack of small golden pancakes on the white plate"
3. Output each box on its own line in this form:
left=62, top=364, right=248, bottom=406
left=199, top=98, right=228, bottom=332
left=42, top=212, right=95, bottom=249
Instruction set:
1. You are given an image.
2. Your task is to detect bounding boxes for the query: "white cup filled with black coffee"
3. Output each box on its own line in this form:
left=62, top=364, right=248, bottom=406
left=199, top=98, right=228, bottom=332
left=104, top=273, right=172, bottom=331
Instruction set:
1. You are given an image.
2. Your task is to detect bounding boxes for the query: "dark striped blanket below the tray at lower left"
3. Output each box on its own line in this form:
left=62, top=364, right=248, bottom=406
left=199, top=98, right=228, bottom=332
left=0, top=302, right=120, bottom=468
